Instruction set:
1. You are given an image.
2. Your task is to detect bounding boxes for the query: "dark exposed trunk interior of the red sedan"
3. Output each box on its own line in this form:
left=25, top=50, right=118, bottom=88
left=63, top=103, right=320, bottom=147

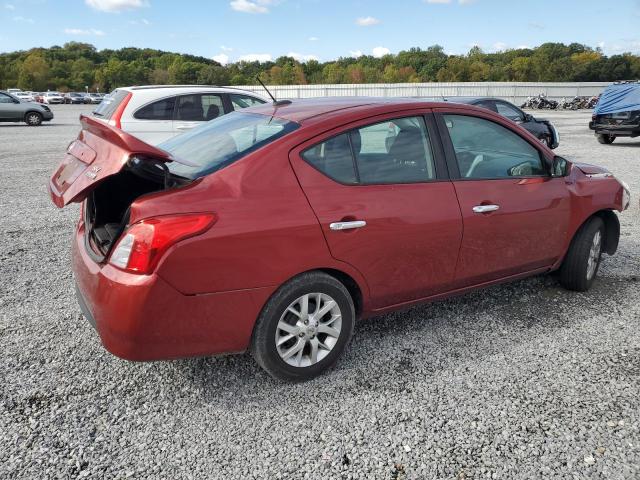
left=84, top=160, right=185, bottom=261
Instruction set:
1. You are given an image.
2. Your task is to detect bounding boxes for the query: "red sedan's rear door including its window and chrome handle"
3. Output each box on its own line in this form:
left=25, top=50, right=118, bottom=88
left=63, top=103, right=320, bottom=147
left=290, top=112, right=462, bottom=308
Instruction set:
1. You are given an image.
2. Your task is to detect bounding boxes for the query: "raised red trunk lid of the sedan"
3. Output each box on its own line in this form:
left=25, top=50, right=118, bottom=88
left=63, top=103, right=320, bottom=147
left=49, top=115, right=178, bottom=208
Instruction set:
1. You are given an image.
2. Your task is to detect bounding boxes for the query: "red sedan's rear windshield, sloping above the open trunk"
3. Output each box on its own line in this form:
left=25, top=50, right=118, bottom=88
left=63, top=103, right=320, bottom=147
left=159, top=112, right=298, bottom=179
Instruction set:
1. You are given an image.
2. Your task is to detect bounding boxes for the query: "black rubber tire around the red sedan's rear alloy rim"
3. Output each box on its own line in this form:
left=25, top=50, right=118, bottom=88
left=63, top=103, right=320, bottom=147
left=251, top=272, right=355, bottom=382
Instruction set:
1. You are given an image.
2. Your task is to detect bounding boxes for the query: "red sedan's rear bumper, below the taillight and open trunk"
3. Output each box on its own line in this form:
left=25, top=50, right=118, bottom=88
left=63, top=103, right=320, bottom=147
left=72, top=226, right=273, bottom=361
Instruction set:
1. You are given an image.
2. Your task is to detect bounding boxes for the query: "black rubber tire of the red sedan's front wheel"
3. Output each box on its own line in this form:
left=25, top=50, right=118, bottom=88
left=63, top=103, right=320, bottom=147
left=560, top=217, right=605, bottom=292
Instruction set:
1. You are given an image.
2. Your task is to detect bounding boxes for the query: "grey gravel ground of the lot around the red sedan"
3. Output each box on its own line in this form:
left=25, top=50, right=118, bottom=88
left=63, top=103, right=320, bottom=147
left=0, top=105, right=640, bottom=480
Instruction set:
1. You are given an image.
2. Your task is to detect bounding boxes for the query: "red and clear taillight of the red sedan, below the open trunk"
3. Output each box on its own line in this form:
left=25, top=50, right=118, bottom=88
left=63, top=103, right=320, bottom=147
left=109, top=213, right=216, bottom=274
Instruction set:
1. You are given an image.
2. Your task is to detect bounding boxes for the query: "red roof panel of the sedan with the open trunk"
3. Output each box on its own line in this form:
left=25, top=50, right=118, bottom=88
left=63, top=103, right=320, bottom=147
left=245, top=97, right=450, bottom=123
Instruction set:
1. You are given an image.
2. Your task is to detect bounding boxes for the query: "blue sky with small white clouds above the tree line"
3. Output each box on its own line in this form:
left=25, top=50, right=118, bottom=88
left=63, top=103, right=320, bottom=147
left=0, top=0, right=640, bottom=64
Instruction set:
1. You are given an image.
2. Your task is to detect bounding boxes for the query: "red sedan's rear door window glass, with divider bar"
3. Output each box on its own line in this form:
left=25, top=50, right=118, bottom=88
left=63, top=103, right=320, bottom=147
left=302, top=117, right=436, bottom=185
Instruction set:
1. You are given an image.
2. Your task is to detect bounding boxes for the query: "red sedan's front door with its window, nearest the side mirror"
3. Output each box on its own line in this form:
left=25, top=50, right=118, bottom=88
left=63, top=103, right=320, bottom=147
left=437, top=109, right=570, bottom=287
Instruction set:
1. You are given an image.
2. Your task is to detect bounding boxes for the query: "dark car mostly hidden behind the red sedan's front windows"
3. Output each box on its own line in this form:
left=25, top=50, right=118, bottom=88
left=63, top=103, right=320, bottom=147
left=446, top=97, right=560, bottom=149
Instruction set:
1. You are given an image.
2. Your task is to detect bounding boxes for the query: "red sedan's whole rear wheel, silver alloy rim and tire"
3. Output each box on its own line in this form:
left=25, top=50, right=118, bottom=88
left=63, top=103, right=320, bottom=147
left=251, top=272, right=355, bottom=381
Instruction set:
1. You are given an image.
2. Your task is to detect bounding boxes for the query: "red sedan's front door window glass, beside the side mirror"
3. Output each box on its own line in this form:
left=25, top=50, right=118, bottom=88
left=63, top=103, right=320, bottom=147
left=444, top=115, right=547, bottom=179
